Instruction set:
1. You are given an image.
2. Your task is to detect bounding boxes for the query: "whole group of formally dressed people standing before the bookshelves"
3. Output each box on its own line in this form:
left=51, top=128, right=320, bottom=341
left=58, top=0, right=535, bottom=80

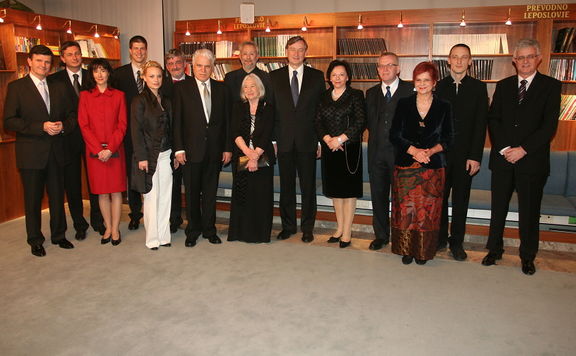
left=4, top=36, right=560, bottom=274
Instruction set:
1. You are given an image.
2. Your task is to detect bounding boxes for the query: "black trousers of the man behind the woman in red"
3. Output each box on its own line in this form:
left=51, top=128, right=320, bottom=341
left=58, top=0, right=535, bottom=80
left=64, top=147, right=104, bottom=231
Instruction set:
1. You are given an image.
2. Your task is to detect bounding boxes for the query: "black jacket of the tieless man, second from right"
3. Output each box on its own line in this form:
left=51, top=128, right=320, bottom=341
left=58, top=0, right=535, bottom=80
left=436, top=75, right=488, bottom=163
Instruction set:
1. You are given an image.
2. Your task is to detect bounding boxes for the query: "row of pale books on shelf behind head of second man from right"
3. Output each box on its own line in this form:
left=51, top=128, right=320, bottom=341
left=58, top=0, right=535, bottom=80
left=432, top=33, right=508, bottom=55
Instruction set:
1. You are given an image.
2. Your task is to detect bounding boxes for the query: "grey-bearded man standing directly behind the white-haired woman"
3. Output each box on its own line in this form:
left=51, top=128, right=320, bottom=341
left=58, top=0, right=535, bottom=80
left=224, top=41, right=271, bottom=103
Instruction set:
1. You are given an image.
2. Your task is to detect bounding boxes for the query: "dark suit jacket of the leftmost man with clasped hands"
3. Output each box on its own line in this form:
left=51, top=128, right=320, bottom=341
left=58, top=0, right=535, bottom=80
left=4, top=75, right=76, bottom=169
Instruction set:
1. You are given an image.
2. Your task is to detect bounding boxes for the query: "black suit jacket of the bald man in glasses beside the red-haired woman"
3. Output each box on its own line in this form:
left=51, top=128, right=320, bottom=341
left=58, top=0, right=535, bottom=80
left=366, top=79, right=414, bottom=165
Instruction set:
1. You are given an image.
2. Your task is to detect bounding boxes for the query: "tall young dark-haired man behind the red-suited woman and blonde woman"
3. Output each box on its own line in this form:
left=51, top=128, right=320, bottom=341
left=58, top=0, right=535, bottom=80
left=111, top=36, right=148, bottom=230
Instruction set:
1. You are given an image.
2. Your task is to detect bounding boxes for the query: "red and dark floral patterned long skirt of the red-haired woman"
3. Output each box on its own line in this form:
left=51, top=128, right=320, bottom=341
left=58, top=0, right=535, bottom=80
left=391, top=162, right=445, bottom=260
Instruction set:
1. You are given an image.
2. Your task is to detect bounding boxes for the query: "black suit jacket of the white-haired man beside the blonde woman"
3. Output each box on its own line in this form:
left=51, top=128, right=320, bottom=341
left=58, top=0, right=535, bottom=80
left=172, top=77, right=232, bottom=163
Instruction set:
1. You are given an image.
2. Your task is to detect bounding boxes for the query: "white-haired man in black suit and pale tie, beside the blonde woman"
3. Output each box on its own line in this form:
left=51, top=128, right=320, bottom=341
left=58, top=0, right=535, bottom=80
left=173, top=49, right=232, bottom=247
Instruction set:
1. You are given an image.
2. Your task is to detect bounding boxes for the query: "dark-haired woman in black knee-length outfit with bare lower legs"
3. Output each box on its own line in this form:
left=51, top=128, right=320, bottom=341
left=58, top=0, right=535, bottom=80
left=316, top=60, right=366, bottom=248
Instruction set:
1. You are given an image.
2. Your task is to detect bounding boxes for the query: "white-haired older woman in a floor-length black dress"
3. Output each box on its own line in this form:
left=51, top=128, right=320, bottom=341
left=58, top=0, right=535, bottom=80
left=228, top=74, right=276, bottom=242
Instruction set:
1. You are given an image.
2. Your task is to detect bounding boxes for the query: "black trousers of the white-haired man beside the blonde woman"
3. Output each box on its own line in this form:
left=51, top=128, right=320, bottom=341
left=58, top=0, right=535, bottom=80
left=183, top=160, right=222, bottom=239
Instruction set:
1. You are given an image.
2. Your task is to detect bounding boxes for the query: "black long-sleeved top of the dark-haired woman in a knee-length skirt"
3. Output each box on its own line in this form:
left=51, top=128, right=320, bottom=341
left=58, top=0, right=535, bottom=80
left=316, top=87, right=366, bottom=142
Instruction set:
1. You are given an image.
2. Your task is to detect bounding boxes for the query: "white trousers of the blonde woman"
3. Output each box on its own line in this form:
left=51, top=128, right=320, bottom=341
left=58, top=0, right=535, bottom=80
left=143, top=150, right=172, bottom=248
